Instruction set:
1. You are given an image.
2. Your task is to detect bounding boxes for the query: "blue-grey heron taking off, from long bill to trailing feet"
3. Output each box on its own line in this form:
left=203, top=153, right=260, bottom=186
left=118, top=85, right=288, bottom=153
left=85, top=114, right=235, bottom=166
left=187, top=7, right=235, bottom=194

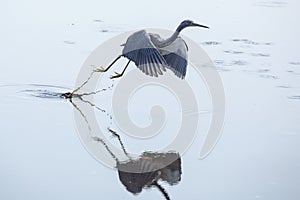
left=95, top=20, right=209, bottom=79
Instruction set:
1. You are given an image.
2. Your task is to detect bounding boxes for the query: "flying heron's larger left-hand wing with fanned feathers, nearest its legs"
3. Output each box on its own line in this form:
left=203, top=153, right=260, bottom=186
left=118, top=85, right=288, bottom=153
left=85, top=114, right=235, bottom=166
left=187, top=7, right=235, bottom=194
left=122, top=30, right=167, bottom=76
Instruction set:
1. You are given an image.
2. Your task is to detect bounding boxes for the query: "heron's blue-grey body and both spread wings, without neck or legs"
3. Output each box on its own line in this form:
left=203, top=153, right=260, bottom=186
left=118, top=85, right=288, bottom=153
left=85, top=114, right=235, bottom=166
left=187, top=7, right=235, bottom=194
left=122, top=30, right=187, bottom=78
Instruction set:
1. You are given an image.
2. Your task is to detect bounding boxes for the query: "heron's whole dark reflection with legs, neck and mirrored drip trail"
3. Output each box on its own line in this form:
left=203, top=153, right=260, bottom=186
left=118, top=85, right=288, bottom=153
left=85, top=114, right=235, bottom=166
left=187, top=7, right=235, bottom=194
left=67, top=98, right=182, bottom=200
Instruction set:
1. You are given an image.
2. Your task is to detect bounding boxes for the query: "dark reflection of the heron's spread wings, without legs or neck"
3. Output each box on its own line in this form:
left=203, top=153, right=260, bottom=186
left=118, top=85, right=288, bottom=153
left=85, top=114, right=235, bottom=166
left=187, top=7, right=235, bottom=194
left=117, top=152, right=181, bottom=194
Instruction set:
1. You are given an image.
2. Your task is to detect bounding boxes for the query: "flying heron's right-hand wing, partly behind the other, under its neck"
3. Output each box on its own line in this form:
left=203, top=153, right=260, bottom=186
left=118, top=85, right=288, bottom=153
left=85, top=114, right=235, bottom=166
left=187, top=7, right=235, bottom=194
left=159, top=37, right=188, bottom=79
